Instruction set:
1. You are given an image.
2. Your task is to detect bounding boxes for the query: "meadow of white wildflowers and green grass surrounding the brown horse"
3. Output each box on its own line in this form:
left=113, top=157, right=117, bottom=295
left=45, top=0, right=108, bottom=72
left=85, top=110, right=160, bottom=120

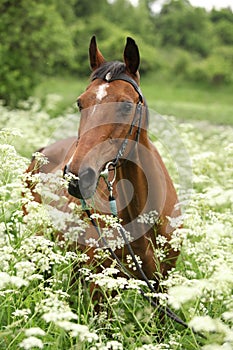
left=0, top=78, right=233, bottom=350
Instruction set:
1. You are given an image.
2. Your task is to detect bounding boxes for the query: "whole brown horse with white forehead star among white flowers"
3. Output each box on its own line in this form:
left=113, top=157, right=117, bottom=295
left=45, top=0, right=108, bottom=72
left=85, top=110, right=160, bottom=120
left=28, top=37, right=180, bottom=292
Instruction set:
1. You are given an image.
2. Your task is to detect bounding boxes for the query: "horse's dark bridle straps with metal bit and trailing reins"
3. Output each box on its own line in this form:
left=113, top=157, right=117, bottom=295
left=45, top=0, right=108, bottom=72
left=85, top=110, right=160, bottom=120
left=81, top=73, right=189, bottom=329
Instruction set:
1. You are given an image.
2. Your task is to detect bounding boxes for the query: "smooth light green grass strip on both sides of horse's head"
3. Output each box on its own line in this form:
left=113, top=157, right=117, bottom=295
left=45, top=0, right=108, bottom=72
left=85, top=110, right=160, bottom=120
left=35, top=74, right=233, bottom=125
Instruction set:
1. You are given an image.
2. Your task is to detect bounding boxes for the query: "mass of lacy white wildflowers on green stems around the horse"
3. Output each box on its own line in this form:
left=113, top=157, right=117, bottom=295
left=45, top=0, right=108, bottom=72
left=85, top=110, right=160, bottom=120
left=0, top=99, right=233, bottom=350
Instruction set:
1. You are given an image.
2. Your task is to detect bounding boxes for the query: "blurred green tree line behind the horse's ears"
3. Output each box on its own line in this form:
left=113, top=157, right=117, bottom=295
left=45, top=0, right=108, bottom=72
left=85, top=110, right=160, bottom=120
left=0, top=0, right=233, bottom=106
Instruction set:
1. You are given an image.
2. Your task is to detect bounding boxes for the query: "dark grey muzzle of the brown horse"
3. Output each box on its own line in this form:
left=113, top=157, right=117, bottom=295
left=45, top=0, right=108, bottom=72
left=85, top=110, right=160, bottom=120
left=63, top=165, right=98, bottom=199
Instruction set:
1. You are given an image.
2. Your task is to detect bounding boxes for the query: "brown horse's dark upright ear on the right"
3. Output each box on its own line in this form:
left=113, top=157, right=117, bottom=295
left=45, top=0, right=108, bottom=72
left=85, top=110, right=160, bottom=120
left=124, top=37, right=140, bottom=74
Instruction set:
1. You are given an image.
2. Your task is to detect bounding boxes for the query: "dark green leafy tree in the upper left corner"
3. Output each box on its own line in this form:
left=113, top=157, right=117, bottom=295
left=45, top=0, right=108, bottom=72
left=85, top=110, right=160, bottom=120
left=0, top=0, right=73, bottom=106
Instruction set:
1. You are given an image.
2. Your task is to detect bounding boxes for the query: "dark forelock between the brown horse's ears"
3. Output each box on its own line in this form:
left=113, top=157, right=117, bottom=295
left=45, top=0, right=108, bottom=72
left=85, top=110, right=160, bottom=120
left=91, top=61, right=126, bottom=80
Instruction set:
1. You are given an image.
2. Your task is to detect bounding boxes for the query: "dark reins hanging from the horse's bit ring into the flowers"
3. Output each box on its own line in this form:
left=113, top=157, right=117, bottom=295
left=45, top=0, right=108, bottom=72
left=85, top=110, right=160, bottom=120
left=81, top=162, right=189, bottom=329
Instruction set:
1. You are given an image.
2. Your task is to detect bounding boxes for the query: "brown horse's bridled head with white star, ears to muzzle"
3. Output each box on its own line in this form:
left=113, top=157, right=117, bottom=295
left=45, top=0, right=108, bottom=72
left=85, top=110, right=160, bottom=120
left=64, top=36, right=145, bottom=199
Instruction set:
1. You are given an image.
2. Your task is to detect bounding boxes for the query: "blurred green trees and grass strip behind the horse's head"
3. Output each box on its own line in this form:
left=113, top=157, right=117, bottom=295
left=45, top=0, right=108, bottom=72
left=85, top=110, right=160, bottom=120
left=0, top=0, right=233, bottom=124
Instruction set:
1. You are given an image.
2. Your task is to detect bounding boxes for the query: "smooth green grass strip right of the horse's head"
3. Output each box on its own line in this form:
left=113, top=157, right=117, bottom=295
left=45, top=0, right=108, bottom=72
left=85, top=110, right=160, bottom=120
left=142, top=76, right=233, bottom=125
